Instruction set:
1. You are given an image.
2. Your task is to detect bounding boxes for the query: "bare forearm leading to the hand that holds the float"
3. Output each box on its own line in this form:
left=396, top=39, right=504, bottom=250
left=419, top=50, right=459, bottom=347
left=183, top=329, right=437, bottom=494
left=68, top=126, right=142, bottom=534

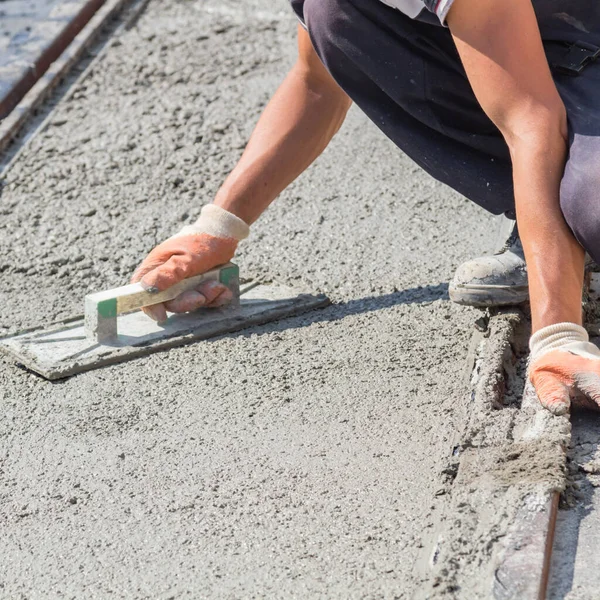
left=215, top=65, right=350, bottom=224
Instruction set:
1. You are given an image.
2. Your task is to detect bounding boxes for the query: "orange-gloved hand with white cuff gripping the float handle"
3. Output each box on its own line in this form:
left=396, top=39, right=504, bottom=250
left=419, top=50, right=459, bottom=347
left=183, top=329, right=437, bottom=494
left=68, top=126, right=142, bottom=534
left=131, top=204, right=250, bottom=323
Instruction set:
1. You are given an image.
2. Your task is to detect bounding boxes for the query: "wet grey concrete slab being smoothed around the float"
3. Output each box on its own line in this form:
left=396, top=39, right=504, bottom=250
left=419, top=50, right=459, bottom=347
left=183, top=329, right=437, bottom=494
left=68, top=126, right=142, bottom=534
left=0, top=0, right=502, bottom=598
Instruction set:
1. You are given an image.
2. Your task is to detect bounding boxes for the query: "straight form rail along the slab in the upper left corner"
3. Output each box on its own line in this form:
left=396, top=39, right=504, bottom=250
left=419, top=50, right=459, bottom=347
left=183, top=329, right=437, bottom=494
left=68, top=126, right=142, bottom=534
left=0, top=0, right=131, bottom=157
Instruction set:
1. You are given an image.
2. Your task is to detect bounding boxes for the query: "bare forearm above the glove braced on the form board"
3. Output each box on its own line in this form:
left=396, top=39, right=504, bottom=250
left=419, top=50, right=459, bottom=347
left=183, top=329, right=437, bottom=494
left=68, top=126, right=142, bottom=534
left=511, top=127, right=585, bottom=332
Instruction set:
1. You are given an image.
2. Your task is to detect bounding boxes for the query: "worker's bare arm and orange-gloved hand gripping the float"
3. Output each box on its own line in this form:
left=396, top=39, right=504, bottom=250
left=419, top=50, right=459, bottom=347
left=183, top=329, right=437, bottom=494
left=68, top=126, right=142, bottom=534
left=132, top=26, right=351, bottom=321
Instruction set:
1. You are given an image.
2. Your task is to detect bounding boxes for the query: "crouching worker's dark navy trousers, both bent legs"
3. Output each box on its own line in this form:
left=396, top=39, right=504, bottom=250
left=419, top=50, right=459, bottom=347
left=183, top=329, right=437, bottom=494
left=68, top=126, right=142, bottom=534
left=294, top=0, right=600, bottom=262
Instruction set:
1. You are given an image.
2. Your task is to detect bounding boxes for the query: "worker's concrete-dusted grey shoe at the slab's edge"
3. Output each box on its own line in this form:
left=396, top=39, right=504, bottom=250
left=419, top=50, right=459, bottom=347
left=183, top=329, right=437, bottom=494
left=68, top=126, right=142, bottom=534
left=449, top=221, right=529, bottom=306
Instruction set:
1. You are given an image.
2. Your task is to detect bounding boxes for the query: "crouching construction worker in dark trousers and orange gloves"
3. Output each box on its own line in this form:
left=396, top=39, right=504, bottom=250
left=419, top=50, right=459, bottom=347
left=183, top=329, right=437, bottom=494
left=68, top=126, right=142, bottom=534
left=133, top=0, right=600, bottom=414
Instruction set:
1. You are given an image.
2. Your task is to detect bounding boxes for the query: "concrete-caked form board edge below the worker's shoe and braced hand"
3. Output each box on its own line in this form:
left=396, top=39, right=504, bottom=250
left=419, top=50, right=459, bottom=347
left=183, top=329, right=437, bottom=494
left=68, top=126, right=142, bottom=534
left=422, top=307, right=570, bottom=600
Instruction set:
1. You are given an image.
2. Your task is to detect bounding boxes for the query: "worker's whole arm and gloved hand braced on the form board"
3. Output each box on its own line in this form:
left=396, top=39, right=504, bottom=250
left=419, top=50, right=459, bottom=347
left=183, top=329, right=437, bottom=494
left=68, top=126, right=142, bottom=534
left=448, top=0, right=600, bottom=414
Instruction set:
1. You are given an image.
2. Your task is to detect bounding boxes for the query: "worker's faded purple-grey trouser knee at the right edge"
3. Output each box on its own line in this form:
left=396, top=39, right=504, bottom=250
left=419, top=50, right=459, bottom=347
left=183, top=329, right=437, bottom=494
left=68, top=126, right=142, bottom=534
left=560, top=153, right=600, bottom=264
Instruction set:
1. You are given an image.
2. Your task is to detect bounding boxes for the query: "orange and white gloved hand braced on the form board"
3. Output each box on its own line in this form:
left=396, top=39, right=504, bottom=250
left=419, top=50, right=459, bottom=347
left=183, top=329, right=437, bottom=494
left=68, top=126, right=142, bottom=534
left=529, top=323, right=600, bottom=415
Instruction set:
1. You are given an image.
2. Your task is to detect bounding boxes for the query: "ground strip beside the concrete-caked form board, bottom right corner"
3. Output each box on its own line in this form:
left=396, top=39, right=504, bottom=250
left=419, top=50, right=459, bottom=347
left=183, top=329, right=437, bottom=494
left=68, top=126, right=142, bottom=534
left=548, top=411, right=600, bottom=600
